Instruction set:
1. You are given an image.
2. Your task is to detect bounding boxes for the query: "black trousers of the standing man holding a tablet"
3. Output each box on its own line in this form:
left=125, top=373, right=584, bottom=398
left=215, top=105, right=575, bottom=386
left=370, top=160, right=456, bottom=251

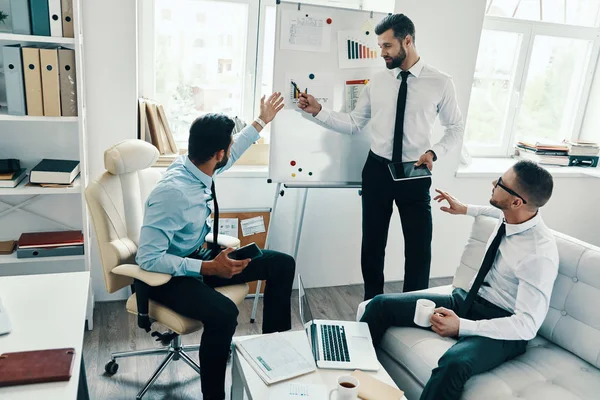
left=361, top=153, right=433, bottom=300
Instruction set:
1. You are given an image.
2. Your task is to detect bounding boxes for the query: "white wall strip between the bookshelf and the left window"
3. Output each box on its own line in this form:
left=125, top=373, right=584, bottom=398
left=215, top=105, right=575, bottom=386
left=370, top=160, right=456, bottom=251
left=82, top=0, right=137, bottom=301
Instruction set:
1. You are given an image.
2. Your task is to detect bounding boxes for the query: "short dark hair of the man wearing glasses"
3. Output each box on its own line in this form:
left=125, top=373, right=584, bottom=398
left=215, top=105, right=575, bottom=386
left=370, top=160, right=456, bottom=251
left=513, top=160, right=554, bottom=207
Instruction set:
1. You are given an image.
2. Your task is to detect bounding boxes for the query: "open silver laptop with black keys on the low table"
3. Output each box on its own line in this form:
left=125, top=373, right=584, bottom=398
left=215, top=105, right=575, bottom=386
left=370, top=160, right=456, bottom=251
left=298, top=275, right=380, bottom=371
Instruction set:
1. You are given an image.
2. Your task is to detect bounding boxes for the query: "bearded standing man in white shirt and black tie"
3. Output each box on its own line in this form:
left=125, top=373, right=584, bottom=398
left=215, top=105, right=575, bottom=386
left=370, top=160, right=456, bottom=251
left=298, top=14, right=464, bottom=300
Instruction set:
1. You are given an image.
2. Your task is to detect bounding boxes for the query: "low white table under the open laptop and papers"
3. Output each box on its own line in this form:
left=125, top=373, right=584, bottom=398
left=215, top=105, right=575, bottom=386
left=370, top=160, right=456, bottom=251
left=231, top=330, right=406, bottom=400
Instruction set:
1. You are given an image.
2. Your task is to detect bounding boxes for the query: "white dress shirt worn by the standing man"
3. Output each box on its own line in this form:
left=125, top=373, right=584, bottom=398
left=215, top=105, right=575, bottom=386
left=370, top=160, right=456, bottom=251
left=308, top=60, right=464, bottom=161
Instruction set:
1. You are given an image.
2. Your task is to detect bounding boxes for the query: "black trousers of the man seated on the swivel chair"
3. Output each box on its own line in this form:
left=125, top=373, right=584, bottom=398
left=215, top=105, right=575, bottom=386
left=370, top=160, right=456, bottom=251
left=150, top=250, right=296, bottom=400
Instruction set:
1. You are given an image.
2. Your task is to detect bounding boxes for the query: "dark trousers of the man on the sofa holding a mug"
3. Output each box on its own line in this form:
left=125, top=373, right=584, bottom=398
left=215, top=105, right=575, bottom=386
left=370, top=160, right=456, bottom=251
left=361, top=289, right=527, bottom=400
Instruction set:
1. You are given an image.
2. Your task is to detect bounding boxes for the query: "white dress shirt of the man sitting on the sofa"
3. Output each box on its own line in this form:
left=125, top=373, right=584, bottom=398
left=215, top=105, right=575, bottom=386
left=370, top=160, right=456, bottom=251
left=459, top=206, right=558, bottom=340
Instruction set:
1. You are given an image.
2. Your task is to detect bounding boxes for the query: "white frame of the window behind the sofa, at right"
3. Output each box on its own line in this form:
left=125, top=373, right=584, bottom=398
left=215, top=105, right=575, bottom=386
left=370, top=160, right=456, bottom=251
left=467, top=16, right=600, bottom=157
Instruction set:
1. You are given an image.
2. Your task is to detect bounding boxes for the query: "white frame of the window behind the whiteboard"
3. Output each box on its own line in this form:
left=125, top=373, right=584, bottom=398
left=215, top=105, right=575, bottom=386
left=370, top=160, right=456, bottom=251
left=138, top=0, right=264, bottom=148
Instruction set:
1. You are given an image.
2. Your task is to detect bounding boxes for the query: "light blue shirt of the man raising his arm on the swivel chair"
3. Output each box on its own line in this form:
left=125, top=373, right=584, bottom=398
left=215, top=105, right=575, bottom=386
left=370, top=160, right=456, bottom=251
left=135, top=125, right=260, bottom=276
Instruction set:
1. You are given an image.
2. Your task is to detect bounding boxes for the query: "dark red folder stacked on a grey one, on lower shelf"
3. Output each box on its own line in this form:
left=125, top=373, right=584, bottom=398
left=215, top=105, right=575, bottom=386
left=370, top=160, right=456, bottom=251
left=17, top=231, right=83, bottom=258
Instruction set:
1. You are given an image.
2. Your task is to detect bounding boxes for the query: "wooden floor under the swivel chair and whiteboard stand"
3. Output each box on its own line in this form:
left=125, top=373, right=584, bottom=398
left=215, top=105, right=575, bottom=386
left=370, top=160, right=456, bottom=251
left=83, top=278, right=452, bottom=400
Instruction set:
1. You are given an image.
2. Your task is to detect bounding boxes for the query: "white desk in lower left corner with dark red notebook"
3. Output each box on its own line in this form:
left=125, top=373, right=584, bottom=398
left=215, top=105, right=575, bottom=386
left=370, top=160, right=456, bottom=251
left=0, top=272, right=90, bottom=400
